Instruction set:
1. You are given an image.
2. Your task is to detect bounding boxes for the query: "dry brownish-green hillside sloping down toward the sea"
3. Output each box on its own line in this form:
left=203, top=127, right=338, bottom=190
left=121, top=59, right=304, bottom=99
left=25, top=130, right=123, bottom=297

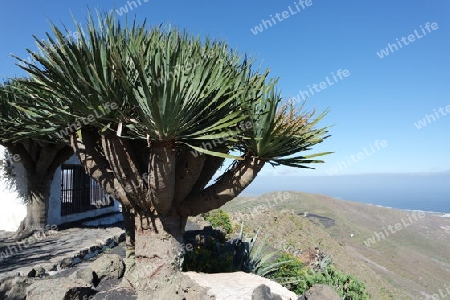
left=222, top=192, right=450, bottom=299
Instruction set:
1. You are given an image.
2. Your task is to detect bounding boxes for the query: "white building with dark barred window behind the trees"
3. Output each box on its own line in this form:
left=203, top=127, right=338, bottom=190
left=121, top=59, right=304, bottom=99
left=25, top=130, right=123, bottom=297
left=0, top=146, right=121, bottom=231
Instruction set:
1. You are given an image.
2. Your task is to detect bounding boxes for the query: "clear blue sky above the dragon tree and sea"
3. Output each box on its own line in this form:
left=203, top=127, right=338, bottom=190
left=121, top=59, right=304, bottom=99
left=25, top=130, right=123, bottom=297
left=0, top=0, right=450, bottom=176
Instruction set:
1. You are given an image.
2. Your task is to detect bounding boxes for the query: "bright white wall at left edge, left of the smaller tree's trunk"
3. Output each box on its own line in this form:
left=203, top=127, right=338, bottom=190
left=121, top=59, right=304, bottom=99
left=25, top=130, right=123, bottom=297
left=0, top=146, right=27, bottom=231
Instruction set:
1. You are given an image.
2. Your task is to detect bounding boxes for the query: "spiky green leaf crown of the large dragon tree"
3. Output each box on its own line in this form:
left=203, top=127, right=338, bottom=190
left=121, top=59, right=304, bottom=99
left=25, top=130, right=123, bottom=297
left=2, top=9, right=328, bottom=168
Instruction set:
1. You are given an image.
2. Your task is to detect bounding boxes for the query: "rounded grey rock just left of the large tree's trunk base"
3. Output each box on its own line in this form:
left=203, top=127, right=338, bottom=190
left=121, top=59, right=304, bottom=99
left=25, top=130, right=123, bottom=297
left=90, top=254, right=125, bottom=282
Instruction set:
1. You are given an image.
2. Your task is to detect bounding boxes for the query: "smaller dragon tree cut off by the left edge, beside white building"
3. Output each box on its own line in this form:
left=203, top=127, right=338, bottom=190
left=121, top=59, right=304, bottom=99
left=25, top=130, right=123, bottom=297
left=0, top=79, right=73, bottom=240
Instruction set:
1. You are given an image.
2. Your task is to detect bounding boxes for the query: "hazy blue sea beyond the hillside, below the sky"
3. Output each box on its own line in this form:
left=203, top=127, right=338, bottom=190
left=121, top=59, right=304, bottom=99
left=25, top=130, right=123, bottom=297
left=242, top=172, right=450, bottom=213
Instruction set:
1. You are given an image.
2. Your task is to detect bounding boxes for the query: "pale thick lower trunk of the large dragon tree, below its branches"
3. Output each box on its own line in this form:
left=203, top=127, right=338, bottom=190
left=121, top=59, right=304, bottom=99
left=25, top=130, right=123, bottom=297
left=125, top=212, right=187, bottom=298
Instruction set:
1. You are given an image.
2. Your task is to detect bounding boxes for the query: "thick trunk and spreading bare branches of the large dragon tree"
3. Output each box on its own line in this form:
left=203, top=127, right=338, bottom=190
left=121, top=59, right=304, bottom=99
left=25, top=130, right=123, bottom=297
left=72, top=129, right=265, bottom=299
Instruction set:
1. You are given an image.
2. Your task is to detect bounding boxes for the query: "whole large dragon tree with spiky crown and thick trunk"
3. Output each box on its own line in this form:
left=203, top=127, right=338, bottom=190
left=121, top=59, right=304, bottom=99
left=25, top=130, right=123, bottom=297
left=10, top=14, right=328, bottom=293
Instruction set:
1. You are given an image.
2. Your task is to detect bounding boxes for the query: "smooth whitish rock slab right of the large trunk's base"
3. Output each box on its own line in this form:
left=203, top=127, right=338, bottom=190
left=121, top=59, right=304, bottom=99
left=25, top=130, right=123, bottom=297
left=183, top=272, right=298, bottom=300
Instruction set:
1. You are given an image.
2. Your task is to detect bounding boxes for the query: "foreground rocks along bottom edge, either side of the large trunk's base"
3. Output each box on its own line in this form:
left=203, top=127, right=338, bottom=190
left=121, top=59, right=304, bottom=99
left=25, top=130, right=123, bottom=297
left=0, top=243, right=340, bottom=300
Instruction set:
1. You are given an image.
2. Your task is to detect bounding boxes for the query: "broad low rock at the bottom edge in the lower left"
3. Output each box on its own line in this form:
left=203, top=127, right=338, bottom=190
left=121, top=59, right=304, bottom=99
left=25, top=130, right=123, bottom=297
left=26, top=278, right=97, bottom=300
